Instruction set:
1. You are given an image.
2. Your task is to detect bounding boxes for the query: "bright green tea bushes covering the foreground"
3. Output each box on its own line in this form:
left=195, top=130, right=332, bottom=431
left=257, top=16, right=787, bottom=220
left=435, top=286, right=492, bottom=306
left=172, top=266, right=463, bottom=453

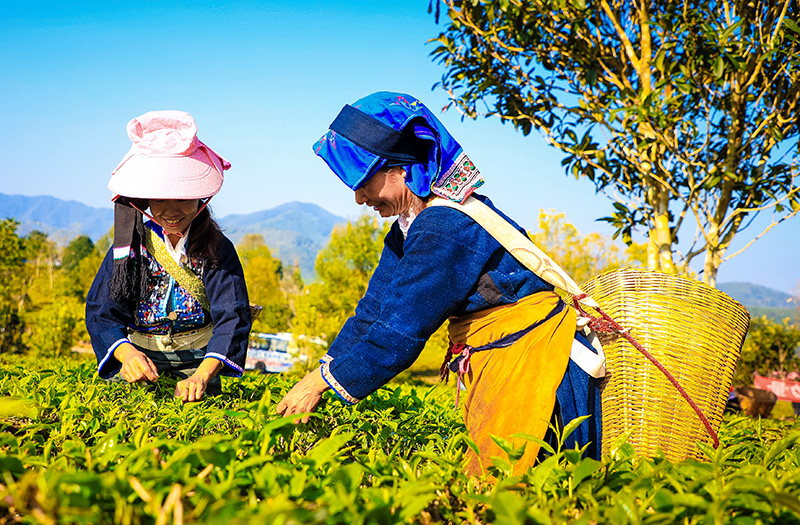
left=0, top=358, right=800, bottom=525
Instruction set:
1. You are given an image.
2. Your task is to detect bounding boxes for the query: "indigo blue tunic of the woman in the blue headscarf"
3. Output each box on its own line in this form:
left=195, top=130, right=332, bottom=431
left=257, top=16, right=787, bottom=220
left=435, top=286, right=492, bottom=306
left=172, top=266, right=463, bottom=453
left=322, top=193, right=600, bottom=457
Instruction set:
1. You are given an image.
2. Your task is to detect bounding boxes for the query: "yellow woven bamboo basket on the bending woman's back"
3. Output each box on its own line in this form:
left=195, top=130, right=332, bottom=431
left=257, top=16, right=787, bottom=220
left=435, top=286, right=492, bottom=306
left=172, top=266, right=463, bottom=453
left=583, top=268, right=750, bottom=461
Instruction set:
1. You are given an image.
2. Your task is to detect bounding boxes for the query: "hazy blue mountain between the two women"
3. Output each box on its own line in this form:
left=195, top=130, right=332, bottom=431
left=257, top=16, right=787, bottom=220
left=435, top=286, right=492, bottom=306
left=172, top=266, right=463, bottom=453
left=219, top=202, right=347, bottom=280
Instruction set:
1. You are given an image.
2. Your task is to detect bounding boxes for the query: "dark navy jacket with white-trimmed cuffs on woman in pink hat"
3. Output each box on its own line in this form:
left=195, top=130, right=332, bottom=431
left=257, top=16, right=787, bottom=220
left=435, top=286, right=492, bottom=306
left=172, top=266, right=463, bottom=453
left=86, top=229, right=252, bottom=379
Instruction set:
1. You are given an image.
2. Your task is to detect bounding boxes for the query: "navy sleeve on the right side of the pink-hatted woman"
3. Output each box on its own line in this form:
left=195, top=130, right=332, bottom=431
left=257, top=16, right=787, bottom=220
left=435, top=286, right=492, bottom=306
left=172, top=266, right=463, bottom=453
left=203, top=238, right=252, bottom=377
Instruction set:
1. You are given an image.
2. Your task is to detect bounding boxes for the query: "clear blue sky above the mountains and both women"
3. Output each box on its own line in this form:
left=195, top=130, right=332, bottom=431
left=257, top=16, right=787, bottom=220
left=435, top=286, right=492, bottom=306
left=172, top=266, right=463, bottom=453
left=0, top=0, right=800, bottom=292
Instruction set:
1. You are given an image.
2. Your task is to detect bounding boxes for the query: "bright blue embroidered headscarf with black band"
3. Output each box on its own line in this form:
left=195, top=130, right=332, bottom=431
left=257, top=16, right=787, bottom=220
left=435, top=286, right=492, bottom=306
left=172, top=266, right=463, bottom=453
left=314, top=91, right=483, bottom=202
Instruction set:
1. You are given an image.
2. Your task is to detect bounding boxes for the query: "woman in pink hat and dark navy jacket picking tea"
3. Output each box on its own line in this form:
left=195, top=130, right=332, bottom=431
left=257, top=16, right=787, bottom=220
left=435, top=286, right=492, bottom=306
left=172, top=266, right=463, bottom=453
left=86, top=111, right=252, bottom=401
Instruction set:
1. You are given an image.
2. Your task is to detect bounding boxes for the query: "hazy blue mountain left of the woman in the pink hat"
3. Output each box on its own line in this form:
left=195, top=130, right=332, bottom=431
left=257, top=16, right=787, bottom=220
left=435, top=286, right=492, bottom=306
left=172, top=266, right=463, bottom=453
left=0, top=193, right=114, bottom=242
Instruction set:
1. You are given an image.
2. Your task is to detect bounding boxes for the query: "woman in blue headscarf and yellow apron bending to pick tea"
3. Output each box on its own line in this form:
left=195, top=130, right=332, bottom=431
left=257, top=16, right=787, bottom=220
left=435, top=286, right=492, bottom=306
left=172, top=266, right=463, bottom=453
left=277, top=92, right=600, bottom=474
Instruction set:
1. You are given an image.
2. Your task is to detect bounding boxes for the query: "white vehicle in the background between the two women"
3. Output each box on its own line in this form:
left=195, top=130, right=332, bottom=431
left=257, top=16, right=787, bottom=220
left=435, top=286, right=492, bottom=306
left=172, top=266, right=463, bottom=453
left=244, top=332, right=327, bottom=374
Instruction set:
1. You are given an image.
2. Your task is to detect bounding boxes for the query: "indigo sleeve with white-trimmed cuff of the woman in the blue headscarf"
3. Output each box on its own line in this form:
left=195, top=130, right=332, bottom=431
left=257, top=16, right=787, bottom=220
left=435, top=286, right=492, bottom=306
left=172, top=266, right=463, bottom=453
left=322, top=207, right=502, bottom=403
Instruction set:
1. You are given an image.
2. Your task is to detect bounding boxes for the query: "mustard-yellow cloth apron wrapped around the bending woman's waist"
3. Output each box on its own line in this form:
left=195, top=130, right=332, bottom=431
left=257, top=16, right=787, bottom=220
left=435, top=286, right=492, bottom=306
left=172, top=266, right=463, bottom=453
left=450, top=292, right=576, bottom=475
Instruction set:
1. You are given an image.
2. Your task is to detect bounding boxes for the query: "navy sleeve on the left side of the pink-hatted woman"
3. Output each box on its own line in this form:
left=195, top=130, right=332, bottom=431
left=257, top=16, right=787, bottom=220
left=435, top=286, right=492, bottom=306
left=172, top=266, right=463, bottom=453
left=86, top=250, right=133, bottom=379
